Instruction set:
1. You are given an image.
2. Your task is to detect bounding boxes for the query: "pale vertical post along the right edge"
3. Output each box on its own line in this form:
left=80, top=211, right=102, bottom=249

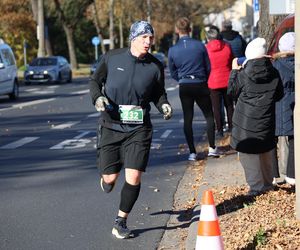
left=294, top=1, right=300, bottom=220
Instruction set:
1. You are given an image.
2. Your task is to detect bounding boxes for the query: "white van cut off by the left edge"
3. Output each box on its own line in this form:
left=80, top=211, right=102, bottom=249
left=0, top=39, right=19, bottom=100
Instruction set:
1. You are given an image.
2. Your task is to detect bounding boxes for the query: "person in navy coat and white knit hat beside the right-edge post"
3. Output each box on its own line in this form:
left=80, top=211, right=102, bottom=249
left=273, top=32, right=295, bottom=185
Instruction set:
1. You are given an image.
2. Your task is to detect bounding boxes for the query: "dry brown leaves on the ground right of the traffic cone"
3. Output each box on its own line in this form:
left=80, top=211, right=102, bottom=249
left=213, top=184, right=300, bottom=250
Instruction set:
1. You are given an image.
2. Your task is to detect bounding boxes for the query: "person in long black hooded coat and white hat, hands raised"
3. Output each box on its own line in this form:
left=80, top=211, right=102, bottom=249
left=228, top=37, right=283, bottom=196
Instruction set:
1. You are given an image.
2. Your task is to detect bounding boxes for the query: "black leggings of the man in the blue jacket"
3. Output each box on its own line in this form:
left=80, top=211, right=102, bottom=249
left=179, top=83, right=215, bottom=153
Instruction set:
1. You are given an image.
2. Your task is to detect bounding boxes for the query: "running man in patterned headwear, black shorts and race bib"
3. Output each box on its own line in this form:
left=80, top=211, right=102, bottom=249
left=90, top=21, right=172, bottom=239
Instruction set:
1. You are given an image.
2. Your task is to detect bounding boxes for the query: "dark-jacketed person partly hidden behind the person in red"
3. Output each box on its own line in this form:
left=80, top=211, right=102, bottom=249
left=221, top=20, right=247, bottom=57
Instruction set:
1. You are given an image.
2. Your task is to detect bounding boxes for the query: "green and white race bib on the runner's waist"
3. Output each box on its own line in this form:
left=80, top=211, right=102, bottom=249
left=119, top=105, right=144, bottom=124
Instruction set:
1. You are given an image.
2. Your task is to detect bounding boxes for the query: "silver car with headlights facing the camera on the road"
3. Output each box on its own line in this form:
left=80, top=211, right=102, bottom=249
left=24, top=56, right=72, bottom=84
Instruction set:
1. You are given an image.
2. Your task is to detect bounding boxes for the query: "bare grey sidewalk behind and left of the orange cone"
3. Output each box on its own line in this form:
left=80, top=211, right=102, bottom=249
left=185, top=153, right=246, bottom=250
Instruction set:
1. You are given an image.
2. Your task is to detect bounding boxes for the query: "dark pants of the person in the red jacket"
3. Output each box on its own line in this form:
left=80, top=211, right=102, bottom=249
left=210, top=88, right=233, bottom=132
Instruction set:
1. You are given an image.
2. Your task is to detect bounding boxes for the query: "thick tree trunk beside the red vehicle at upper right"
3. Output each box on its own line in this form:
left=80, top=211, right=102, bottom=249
left=258, top=0, right=286, bottom=47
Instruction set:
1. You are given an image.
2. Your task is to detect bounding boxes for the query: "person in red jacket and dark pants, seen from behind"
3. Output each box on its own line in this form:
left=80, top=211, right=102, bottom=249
left=206, top=28, right=233, bottom=138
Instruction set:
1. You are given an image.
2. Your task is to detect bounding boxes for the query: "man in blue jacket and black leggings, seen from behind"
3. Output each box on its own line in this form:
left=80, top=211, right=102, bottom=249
left=168, top=17, right=219, bottom=161
